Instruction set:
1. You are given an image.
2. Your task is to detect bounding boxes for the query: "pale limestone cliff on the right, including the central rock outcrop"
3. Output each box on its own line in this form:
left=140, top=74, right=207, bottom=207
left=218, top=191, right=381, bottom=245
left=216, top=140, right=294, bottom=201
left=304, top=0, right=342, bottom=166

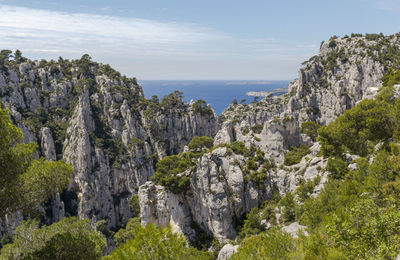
left=139, top=35, right=400, bottom=240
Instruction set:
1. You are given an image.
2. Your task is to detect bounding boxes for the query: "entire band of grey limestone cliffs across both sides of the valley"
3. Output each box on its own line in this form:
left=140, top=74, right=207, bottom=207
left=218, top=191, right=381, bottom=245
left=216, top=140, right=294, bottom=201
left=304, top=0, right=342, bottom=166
left=0, top=35, right=400, bottom=246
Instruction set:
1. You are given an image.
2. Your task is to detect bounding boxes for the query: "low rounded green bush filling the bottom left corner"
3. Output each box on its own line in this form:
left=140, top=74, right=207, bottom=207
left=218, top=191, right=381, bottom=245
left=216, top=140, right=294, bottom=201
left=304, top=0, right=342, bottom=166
left=0, top=217, right=106, bottom=260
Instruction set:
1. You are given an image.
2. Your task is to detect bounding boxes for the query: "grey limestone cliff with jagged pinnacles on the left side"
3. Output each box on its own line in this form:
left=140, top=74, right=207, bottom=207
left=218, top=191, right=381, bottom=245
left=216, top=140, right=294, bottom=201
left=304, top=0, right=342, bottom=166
left=0, top=56, right=218, bottom=234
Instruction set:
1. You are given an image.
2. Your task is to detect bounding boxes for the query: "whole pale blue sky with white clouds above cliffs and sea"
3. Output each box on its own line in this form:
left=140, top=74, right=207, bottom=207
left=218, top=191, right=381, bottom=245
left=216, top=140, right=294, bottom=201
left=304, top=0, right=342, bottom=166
left=0, top=0, right=400, bottom=80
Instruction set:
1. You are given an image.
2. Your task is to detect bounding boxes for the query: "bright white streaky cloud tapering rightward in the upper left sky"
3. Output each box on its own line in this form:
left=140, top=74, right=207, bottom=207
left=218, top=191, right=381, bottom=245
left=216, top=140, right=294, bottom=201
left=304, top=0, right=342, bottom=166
left=0, top=5, right=220, bottom=56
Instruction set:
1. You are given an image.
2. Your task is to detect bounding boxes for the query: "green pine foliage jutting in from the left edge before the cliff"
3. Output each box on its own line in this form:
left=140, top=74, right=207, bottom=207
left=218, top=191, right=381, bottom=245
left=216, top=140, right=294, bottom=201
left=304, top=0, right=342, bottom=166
left=0, top=105, right=73, bottom=216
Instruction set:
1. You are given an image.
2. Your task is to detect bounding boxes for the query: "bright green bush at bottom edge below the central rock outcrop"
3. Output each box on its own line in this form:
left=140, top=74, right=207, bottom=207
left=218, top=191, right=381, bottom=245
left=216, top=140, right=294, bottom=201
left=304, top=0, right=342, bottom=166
left=104, top=224, right=212, bottom=260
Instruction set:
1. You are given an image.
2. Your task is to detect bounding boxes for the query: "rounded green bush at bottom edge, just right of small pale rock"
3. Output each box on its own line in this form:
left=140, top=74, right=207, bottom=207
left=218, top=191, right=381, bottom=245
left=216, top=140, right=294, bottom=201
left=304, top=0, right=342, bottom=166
left=231, top=228, right=296, bottom=260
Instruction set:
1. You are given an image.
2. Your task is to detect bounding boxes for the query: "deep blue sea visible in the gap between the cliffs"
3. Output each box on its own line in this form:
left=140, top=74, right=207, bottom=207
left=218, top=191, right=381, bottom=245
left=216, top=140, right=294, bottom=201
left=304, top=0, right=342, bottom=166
left=139, top=80, right=289, bottom=115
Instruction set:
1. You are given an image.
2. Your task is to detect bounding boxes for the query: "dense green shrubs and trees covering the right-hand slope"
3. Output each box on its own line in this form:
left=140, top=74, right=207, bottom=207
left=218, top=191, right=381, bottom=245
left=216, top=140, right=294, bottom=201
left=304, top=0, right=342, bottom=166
left=232, top=70, right=400, bottom=259
